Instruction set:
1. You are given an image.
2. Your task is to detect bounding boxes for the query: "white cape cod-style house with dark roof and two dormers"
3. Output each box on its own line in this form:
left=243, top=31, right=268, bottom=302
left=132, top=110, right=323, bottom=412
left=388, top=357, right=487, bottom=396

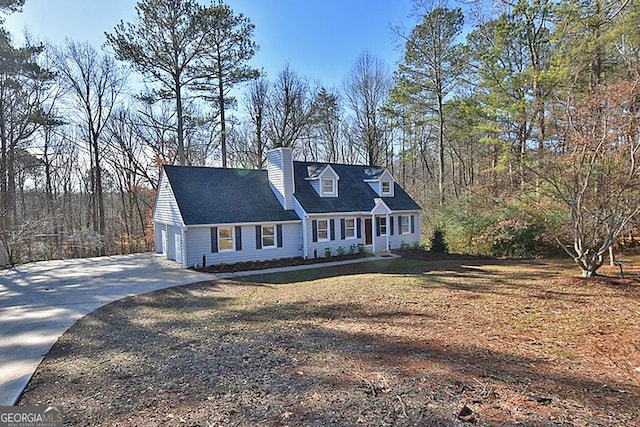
left=153, top=147, right=421, bottom=267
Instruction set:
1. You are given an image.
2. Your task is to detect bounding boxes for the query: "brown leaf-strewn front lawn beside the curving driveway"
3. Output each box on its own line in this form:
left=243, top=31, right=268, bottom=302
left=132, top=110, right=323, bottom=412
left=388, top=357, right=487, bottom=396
left=19, top=259, right=640, bottom=426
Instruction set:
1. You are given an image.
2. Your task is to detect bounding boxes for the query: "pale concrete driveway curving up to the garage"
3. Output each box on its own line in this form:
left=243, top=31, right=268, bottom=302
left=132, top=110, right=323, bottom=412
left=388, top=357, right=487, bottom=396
left=0, top=253, right=206, bottom=406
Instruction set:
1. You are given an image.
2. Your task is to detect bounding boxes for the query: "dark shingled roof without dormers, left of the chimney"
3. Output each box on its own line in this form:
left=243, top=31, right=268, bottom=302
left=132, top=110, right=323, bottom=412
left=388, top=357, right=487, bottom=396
left=164, top=166, right=299, bottom=225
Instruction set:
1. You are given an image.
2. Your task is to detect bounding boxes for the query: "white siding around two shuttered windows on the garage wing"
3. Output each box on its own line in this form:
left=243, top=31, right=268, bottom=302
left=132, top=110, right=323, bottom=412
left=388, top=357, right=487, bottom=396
left=183, top=222, right=302, bottom=267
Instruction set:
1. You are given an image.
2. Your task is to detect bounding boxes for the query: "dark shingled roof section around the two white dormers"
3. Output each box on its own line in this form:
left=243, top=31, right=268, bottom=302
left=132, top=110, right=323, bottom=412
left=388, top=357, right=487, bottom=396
left=293, top=162, right=421, bottom=213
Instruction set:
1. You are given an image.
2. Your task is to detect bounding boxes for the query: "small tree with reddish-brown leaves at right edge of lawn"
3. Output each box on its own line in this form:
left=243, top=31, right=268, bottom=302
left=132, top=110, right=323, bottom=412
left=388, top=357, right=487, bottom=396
left=534, top=80, right=640, bottom=277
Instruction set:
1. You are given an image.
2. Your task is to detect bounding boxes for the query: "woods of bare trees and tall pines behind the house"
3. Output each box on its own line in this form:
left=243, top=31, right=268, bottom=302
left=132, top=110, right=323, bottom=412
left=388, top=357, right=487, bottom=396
left=0, top=0, right=640, bottom=276
